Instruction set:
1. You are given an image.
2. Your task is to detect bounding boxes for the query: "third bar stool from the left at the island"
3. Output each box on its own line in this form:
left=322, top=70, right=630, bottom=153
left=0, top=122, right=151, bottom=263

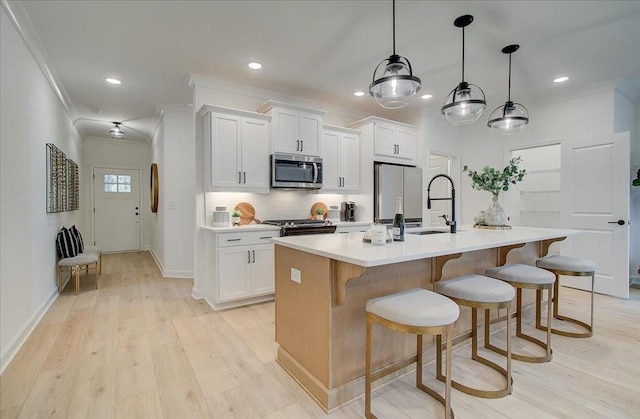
left=485, top=263, right=556, bottom=362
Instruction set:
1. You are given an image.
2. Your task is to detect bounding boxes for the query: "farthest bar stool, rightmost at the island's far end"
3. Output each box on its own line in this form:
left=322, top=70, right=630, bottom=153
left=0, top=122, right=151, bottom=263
left=536, top=255, right=596, bottom=338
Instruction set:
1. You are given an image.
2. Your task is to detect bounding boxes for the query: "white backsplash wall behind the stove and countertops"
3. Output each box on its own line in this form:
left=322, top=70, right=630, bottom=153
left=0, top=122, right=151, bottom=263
left=205, top=190, right=362, bottom=226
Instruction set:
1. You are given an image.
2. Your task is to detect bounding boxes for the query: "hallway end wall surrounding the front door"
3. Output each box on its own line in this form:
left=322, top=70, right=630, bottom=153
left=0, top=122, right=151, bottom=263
left=80, top=137, right=151, bottom=249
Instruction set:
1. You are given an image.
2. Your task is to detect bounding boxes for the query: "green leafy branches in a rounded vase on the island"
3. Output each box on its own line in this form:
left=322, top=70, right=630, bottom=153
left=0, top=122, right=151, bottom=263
left=462, top=156, right=526, bottom=226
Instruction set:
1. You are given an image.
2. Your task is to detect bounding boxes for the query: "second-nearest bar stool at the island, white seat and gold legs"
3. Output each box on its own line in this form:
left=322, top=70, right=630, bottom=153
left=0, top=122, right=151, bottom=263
left=435, top=274, right=515, bottom=399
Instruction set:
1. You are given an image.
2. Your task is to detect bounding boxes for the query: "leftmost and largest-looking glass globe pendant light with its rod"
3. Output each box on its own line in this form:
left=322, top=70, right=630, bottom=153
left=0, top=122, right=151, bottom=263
left=369, top=0, right=422, bottom=109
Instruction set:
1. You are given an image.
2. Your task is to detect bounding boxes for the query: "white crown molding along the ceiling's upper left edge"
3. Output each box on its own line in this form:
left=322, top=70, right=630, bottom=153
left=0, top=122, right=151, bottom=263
left=1, top=0, right=78, bottom=121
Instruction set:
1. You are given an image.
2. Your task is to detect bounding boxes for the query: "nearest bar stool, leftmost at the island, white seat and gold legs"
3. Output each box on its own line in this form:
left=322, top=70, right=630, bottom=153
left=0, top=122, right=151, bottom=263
left=364, top=288, right=460, bottom=419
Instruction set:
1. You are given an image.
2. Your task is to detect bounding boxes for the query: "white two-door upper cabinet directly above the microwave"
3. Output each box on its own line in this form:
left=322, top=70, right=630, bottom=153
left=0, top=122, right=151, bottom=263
left=258, top=100, right=326, bottom=156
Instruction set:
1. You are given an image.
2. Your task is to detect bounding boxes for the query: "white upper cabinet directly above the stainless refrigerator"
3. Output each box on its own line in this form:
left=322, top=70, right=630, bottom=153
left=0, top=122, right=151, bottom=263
left=350, top=117, right=418, bottom=164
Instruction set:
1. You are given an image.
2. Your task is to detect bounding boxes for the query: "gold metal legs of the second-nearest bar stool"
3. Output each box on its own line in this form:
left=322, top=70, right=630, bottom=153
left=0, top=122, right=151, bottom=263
left=436, top=304, right=513, bottom=399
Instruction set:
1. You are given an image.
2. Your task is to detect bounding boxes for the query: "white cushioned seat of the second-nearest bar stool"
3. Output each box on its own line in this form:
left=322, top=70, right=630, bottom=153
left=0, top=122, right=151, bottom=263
left=436, top=274, right=516, bottom=303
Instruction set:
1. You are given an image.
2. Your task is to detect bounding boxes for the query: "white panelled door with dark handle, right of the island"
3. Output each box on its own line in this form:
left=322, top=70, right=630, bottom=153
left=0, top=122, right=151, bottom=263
left=561, top=132, right=630, bottom=298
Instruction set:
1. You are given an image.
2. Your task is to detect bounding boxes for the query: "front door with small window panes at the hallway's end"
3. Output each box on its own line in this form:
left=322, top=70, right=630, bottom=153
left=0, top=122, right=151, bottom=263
left=93, top=168, right=141, bottom=252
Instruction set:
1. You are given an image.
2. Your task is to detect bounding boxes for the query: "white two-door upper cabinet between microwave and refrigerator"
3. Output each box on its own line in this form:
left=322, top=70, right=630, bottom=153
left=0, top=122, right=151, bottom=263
left=322, top=126, right=360, bottom=193
